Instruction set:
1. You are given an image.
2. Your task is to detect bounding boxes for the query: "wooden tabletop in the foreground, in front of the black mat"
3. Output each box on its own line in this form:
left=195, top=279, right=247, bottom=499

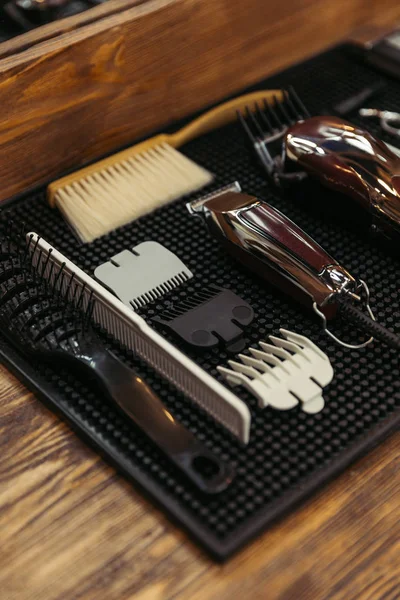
left=0, top=358, right=400, bottom=600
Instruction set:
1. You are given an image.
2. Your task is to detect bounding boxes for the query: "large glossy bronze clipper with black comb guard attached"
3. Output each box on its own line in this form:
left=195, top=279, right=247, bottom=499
left=238, top=89, right=400, bottom=239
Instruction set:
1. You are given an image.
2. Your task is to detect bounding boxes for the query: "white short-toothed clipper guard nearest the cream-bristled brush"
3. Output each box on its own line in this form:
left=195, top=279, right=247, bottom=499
left=94, top=241, right=193, bottom=310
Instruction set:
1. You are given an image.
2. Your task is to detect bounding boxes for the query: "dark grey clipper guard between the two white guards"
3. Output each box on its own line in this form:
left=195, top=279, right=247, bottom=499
left=152, top=285, right=254, bottom=352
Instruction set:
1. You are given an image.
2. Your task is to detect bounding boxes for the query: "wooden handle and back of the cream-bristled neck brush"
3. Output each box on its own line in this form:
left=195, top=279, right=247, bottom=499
left=47, top=90, right=282, bottom=207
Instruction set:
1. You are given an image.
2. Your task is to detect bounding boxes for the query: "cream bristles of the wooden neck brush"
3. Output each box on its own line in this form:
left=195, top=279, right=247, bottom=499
left=55, top=144, right=213, bottom=242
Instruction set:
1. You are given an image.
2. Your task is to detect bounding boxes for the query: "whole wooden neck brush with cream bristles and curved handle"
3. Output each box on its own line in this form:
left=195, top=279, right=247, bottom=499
left=48, top=90, right=281, bottom=242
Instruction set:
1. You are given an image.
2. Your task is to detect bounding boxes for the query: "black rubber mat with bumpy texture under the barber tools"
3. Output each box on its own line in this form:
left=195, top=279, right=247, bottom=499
left=0, top=48, right=400, bottom=559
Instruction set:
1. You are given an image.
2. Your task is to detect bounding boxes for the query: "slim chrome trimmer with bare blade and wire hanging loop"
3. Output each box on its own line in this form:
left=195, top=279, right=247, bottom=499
left=187, top=182, right=400, bottom=348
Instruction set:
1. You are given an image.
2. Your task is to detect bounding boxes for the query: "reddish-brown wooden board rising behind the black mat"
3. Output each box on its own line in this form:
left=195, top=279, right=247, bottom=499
left=0, top=0, right=400, bottom=199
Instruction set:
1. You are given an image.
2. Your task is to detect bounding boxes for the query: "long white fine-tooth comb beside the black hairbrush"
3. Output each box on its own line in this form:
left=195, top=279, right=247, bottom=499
left=27, top=233, right=250, bottom=444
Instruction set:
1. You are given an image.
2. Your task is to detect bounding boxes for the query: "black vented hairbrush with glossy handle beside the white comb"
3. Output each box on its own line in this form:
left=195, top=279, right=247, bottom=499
left=0, top=223, right=233, bottom=494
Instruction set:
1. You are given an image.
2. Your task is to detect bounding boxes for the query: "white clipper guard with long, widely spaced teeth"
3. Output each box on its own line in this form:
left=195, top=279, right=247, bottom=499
left=217, top=329, right=334, bottom=414
